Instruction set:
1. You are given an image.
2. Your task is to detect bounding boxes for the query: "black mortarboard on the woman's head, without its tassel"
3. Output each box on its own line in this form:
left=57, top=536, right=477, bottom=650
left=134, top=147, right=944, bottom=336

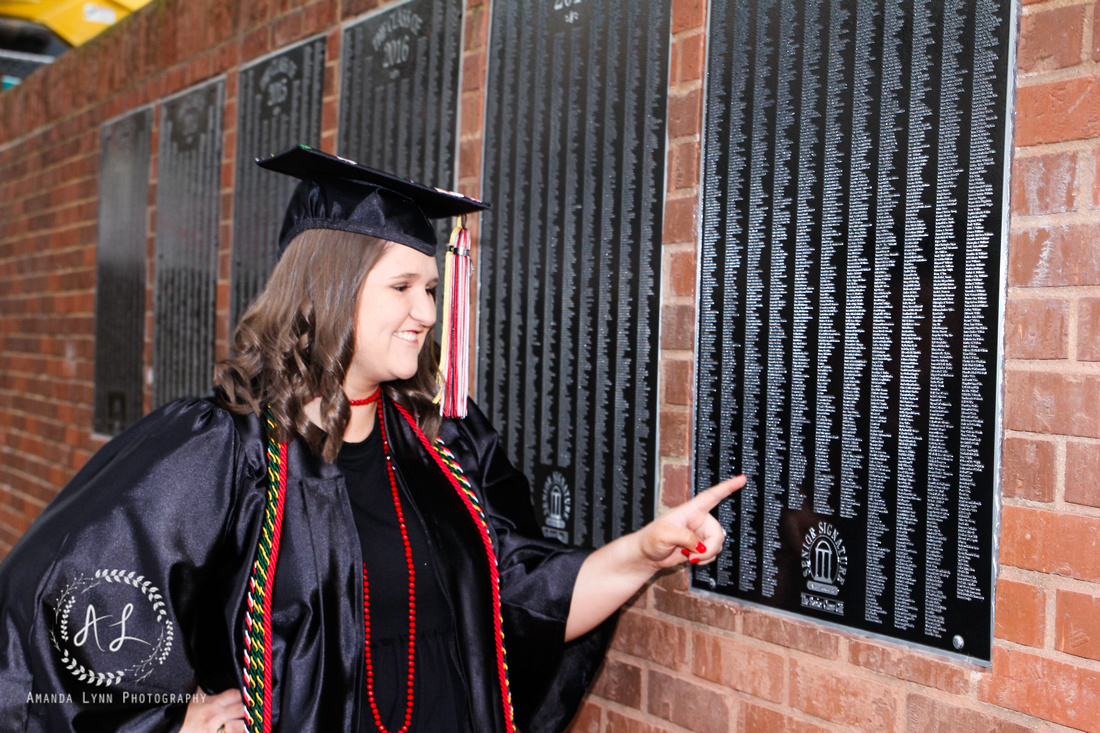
left=256, top=145, right=488, bottom=256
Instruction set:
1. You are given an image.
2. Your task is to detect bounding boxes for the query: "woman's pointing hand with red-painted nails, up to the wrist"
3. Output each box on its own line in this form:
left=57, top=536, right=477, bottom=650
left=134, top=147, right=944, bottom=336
left=636, top=475, right=745, bottom=572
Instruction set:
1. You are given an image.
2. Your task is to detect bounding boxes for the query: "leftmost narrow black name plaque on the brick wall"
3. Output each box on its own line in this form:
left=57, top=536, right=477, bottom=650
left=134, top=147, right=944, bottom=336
left=94, top=108, right=153, bottom=435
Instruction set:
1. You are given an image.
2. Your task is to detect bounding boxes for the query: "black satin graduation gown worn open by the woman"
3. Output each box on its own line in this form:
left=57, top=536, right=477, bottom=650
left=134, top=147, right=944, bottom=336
left=0, top=397, right=613, bottom=733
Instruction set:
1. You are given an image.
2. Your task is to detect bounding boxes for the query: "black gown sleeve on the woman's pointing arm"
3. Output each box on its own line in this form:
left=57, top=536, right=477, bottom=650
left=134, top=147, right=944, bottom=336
left=451, top=402, right=617, bottom=733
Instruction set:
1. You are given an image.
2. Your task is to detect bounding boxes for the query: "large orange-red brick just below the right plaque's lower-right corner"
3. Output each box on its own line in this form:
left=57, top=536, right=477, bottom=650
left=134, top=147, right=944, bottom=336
left=978, top=646, right=1100, bottom=730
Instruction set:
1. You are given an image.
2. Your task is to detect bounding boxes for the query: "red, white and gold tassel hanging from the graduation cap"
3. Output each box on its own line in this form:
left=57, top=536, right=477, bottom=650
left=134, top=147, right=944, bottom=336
left=437, top=216, right=470, bottom=417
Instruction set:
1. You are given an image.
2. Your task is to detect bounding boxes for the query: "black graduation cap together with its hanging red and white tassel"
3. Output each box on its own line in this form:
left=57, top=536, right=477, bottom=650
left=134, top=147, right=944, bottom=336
left=256, top=145, right=488, bottom=417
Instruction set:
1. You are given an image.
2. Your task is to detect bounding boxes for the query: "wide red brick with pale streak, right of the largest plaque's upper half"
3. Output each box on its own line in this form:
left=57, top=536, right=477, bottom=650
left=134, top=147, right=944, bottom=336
left=1009, top=225, right=1100, bottom=287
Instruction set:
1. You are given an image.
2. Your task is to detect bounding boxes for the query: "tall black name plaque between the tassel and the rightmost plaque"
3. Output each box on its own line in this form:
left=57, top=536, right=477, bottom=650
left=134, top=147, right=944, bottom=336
left=477, top=0, right=670, bottom=545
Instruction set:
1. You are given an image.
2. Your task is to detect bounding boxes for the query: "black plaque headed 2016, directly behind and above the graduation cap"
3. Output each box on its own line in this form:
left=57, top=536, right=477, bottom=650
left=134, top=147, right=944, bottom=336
left=339, top=0, right=463, bottom=250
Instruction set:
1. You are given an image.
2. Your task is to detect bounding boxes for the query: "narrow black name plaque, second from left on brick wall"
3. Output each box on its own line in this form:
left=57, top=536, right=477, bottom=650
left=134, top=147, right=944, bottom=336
left=153, top=84, right=226, bottom=406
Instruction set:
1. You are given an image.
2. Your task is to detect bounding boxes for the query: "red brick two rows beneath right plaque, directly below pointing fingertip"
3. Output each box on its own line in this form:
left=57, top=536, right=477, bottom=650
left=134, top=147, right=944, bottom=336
left=692, top=632, right=787, bottom=702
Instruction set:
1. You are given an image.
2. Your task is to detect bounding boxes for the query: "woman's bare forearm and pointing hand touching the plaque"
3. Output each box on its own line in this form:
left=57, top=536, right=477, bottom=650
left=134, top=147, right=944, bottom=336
left=565, top=475, right=745, bottom=642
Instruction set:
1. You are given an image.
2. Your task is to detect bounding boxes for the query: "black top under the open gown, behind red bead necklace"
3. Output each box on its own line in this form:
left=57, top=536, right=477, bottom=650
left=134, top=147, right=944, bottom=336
left=337, top=426, right=470, bottom=733
